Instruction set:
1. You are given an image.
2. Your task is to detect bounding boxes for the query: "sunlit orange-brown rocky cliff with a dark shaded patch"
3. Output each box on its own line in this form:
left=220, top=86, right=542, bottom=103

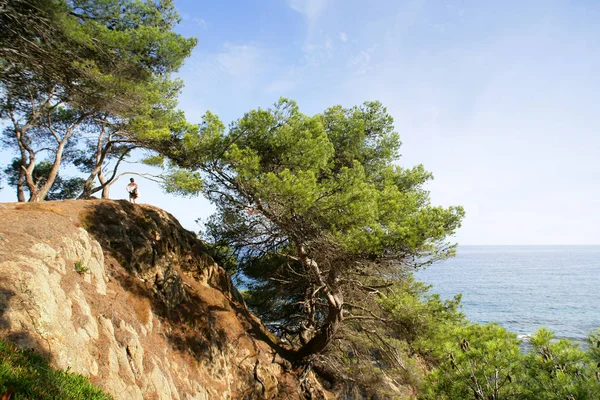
left=0, top=200, right=300, bottom=400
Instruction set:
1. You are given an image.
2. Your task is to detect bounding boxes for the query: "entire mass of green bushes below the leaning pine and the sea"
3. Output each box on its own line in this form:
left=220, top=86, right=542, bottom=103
left=336, top=274, right=600, bottom=400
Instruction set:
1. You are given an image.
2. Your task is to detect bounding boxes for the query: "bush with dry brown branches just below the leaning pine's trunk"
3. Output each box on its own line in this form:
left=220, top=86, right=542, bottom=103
left=318, top=273, right=465, bottom=399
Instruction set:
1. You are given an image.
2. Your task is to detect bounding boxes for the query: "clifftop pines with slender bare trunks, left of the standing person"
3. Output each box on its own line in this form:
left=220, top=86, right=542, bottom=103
left=0, top=0, right=196, bottom=201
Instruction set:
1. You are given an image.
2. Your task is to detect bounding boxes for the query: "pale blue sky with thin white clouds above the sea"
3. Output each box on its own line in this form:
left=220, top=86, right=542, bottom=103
left=0, top=0, right=600, bottom=245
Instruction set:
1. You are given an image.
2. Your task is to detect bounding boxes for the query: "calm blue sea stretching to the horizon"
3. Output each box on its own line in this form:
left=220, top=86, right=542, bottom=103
left=416, top=246, right=600, bottom=340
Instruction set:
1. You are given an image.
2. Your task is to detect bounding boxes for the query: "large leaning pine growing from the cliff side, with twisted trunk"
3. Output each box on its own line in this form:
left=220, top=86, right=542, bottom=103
left=162, top=99, right=463, bottom=361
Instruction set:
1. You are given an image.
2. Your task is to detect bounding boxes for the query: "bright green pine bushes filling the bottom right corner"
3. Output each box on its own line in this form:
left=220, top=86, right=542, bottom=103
left=421, top=324, right=600, bottom=400
